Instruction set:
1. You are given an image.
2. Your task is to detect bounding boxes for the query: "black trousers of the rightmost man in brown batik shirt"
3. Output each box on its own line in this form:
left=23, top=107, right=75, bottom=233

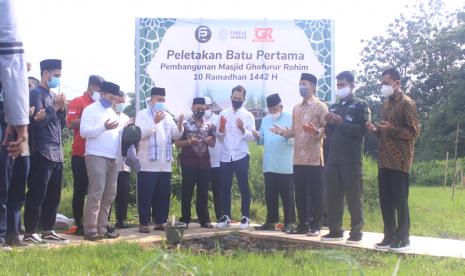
left=378, top=168, right=410, bottom=241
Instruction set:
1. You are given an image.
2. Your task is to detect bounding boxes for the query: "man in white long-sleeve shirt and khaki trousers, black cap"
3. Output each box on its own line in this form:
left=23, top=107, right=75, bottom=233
left=80, top=81, right=123, bottom=241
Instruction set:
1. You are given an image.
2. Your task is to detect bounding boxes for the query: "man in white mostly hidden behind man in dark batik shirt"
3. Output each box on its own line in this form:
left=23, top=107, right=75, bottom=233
left=204, top=97, right=223, bottom=221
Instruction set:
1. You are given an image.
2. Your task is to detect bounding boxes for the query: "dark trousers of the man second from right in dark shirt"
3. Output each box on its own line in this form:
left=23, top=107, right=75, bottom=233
left=325, top=164, right=364, bottom=238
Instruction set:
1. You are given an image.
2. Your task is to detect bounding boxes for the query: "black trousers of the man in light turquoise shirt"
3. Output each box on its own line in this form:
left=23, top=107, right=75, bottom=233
left=263, top=172, right=295, bottom=225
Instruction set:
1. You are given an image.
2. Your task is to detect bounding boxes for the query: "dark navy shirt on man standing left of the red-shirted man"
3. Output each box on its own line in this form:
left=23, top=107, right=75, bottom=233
left=29, top=85, right=66, bottom=162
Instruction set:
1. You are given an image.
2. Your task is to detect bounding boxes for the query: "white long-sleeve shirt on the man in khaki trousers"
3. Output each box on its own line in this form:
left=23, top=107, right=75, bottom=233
left=80, top=101, right=123, bottom=159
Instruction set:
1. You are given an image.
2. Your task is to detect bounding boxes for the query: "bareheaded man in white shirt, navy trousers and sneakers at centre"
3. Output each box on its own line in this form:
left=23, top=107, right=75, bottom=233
left=216, top=85, right=255, bottom=229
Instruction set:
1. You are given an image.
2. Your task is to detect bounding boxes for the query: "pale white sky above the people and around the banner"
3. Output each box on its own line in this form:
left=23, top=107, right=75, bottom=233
left=14, top=0, right=465, bottom=99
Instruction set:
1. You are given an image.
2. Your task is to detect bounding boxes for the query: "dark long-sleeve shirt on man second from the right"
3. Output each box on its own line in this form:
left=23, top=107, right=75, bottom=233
left=325, top=98, right=371, bottom=165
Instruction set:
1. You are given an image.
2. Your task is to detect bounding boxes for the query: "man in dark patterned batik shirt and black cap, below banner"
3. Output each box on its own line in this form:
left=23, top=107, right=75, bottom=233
left=175, top=98, right=215, bottom=228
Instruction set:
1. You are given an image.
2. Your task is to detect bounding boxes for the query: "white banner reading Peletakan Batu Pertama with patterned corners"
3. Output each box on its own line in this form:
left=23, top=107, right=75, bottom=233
left=136, top=18, right=334, bottom=114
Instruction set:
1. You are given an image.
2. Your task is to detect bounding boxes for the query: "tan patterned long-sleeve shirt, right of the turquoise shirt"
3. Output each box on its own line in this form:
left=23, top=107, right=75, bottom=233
left=285, top=98, right=328, bottom=166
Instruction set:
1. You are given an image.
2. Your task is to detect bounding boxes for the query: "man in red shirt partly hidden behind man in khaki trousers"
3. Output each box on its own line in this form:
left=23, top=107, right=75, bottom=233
left=66, top=75, right=104, bottom=235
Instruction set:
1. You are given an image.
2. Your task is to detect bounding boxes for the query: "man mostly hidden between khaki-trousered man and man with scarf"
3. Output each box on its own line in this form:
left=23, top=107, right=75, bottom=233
left=108, top=91, right=134, bottom=229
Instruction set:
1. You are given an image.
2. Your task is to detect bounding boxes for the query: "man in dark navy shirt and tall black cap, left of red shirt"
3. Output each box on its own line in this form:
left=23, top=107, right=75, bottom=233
left=23, top=59, right=66, bottom=243
